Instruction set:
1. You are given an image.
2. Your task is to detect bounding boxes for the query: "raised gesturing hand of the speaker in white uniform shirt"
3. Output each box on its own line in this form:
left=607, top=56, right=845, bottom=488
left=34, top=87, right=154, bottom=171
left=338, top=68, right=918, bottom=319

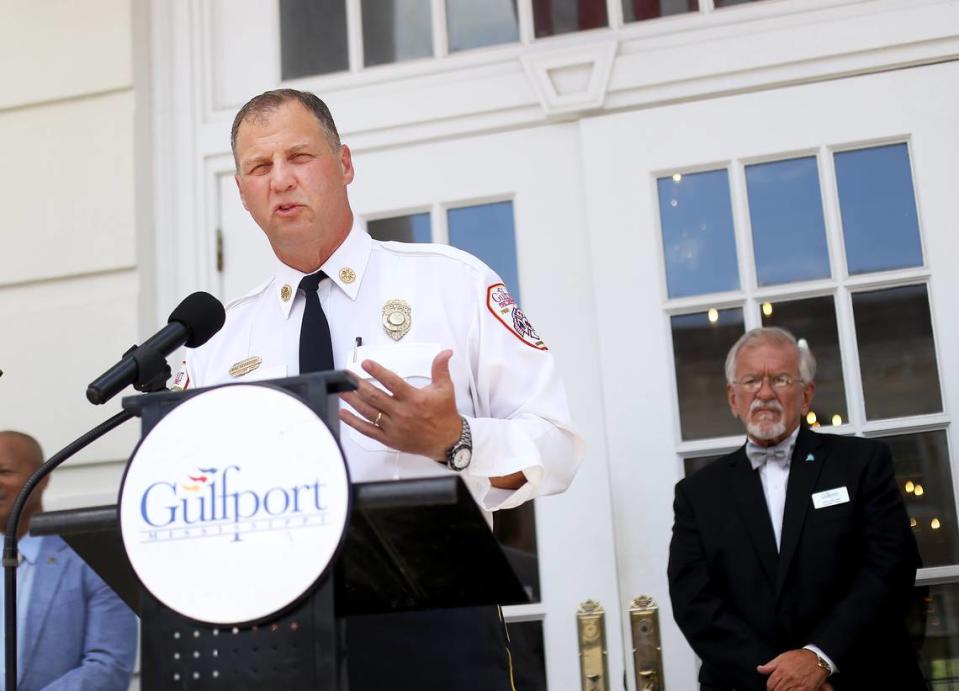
left=340, top=350, right=526, bottom=489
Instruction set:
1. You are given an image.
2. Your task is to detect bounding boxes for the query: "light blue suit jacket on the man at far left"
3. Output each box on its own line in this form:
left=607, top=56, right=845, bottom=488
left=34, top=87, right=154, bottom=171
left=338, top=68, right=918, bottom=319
left=18, top=536, right=137, bottom=691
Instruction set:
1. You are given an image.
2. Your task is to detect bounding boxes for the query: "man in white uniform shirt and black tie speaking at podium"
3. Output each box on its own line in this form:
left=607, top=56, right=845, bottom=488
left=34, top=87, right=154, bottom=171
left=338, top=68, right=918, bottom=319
left=174, top=89, right=579, bottom=691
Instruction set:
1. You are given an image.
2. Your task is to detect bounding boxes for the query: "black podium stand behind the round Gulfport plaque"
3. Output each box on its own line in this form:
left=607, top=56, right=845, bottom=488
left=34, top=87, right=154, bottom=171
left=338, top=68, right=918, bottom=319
left=31, top=372, right=528, bottom=691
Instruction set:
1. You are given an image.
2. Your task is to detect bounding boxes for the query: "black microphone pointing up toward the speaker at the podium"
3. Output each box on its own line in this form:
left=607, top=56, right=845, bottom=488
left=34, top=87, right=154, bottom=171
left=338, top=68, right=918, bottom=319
left=87, top=291, right=226, bottom=405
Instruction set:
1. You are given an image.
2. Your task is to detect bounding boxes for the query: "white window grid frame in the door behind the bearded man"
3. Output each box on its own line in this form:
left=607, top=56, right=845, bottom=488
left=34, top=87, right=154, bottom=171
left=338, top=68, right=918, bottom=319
left=650, top=135, right=959, bottom=585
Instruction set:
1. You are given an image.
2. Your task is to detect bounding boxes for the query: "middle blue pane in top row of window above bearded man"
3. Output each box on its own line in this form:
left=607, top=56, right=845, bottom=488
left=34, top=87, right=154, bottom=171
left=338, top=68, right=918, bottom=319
left=746, top=156, right=829, bottom=286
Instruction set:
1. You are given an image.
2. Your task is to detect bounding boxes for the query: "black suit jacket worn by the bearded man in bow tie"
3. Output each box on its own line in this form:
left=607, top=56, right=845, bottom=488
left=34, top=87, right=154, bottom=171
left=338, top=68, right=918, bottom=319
left=669, top=429, right=926, bottom=691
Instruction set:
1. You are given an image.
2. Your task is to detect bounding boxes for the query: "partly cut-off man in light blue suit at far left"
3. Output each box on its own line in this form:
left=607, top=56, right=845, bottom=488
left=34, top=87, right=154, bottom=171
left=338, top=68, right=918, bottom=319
left=0, top=432, right=137, bottom=691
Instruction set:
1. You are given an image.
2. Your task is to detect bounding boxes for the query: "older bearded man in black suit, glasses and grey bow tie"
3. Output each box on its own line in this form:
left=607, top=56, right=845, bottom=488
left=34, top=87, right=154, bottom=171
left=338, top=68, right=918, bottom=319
left=669, top=328, right=926, bottom=691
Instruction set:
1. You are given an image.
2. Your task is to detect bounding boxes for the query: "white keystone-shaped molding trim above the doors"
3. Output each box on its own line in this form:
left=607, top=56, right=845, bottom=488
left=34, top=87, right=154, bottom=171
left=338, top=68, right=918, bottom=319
left=520, top=40, right=618, bottom=115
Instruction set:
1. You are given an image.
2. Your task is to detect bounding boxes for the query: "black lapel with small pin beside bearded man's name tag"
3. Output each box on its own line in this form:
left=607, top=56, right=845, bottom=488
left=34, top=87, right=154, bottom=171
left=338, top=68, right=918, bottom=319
left=776, top=428, right=826, bottom=596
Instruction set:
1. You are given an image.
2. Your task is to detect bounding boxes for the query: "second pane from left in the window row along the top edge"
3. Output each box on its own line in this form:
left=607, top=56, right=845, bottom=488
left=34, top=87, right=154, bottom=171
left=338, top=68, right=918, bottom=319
left=361, top=0, right=433, bottom=67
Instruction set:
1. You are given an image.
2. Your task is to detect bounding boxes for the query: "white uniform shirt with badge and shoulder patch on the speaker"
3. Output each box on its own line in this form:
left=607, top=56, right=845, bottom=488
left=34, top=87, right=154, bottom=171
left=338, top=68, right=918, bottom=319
left=180, top=225, right=581, bottom=510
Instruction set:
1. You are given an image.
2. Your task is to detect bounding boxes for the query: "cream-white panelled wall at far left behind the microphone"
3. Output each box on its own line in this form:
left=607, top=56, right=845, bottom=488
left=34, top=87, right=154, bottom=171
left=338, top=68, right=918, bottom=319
left=0, top=0, right=141, bottom=508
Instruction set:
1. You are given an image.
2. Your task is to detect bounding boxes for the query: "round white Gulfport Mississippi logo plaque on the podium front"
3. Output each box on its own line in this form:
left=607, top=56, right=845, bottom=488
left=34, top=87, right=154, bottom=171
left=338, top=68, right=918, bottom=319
left=120, top=385, right=350, bottom=625
